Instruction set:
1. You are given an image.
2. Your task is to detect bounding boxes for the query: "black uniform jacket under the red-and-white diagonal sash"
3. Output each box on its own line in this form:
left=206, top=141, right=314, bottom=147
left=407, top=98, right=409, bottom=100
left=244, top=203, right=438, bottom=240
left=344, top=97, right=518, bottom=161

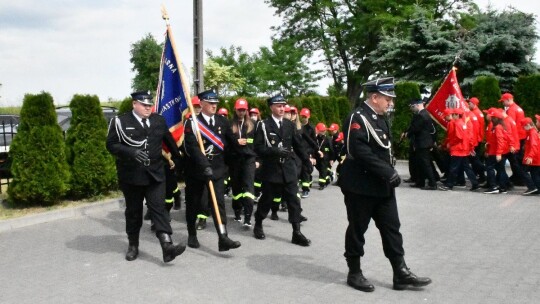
left=184, top=114, right=231, bottom=180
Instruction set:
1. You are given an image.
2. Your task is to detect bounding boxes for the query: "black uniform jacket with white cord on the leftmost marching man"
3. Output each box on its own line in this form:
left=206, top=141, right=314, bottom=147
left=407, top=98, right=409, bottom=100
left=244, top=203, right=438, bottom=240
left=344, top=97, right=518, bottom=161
left=107, top=111, right=180, bottom=185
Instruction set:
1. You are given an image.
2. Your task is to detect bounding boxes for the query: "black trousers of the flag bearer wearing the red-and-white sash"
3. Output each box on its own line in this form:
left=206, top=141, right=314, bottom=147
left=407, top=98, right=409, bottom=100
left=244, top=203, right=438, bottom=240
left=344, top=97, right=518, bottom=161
left=186, top=178, right=227, bottom=235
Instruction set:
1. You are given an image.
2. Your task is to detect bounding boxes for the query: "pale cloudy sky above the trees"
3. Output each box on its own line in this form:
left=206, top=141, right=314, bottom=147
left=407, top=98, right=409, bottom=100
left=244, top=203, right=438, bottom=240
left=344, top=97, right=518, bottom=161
left=0, top=0, right=540, bottom=106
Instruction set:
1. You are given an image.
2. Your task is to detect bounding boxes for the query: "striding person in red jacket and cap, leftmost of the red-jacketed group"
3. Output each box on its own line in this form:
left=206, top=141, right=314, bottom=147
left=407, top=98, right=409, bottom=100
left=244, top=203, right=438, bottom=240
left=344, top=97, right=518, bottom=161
left=439, top=108, right=479, bottom=191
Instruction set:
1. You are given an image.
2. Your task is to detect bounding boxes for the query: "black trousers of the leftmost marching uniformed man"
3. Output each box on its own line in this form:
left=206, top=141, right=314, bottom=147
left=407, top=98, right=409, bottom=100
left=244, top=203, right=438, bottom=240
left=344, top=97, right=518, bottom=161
left=120, top=182, right=172, bottom=239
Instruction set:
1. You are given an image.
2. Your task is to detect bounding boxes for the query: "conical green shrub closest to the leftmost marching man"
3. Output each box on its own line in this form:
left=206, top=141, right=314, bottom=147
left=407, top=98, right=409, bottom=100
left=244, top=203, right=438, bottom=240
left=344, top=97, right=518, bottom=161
left=66, top=95, right=116, bottom=198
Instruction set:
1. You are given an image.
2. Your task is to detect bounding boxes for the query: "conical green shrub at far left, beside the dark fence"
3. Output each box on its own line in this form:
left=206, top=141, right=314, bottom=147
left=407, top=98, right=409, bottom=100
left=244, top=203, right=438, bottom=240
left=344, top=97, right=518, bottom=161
left=8, top=92, right=70, bottom=207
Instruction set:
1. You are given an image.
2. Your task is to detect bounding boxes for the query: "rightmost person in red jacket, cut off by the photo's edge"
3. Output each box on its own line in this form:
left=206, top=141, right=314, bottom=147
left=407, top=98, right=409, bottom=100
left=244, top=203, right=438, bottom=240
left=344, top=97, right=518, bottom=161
left=521, top=117, right=540, bottom=195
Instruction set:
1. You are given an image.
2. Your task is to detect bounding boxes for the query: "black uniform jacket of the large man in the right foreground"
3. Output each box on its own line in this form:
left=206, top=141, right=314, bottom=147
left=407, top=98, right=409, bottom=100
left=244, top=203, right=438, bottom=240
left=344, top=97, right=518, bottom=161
left=338, top=103, right=394, bottom=197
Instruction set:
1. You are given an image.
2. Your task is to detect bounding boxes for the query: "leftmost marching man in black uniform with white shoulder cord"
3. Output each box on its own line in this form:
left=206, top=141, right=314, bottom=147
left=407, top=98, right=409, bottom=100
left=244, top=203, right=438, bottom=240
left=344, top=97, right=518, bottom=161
left=107, top=92, right=186, bottom=262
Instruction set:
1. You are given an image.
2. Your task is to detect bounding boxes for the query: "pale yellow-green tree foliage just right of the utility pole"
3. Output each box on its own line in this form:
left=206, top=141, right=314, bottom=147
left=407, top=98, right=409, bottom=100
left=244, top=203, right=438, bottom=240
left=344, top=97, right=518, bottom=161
left=204, top=59, right=245, bottom=96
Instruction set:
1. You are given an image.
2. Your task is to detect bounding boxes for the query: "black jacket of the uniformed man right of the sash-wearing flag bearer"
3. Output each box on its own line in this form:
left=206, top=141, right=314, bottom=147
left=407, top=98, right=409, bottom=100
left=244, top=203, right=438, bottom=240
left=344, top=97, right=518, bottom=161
left=255, top=117, right=311, bottom=183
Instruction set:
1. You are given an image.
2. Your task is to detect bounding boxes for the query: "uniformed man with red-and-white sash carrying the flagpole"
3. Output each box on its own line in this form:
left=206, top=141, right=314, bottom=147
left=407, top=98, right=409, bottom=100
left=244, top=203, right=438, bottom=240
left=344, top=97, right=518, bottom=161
left=184, top=90, right=240, bottom=251
